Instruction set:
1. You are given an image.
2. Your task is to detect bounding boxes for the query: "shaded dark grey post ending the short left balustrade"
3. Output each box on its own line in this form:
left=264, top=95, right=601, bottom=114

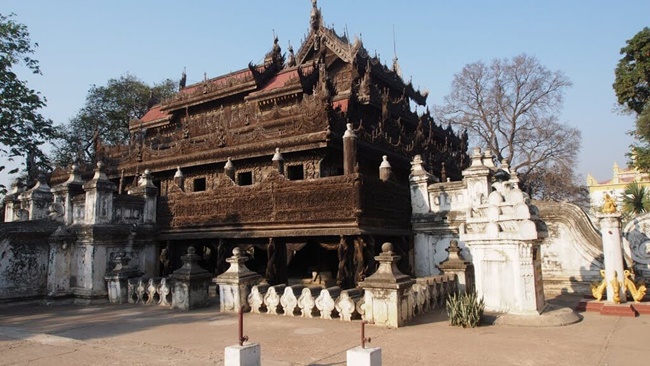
left=171, top=247, right=212, bottom=310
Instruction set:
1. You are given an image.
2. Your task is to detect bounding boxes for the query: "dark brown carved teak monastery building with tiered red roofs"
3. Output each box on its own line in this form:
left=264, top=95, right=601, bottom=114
left=68, top=1, right=468, bottom=288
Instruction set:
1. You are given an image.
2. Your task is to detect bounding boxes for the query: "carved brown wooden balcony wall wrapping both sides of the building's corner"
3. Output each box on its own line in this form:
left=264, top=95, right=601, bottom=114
left=158, top=174, right=410, bottom=239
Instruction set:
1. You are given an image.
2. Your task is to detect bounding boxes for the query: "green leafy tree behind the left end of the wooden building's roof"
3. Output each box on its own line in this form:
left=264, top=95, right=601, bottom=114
left=53, top=74, right=176, bottom=166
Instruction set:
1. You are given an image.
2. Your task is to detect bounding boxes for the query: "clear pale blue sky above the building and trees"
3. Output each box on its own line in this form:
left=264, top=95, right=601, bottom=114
left=0, top=0, right=650, bottom=184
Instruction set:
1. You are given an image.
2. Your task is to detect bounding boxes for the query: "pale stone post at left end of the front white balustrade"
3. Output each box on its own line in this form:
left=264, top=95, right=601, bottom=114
left=214, top=248, right=262, bottom=313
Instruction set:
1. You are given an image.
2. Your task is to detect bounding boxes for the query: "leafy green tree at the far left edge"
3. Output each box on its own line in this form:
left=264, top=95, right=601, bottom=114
left=0, top=14, right=54, bottom=192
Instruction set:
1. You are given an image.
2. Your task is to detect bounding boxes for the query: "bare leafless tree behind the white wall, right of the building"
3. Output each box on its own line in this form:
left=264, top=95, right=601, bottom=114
left=435, top=54, right=581, bottom=196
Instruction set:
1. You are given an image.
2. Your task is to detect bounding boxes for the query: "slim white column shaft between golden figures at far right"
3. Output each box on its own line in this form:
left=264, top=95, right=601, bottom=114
left=598, top=213, right=626, bottom=303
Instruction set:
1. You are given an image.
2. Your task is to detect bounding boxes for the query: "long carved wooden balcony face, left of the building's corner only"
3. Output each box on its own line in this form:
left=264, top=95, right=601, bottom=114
left=158, top=174, right=358, bottom=228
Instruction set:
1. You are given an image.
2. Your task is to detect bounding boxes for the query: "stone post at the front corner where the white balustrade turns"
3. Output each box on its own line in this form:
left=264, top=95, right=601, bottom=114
left=359, top=243, right=415, bottom=328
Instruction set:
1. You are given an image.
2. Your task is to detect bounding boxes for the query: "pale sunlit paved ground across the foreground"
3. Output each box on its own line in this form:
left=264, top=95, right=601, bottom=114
left=0, top=296, right=650, bottom=366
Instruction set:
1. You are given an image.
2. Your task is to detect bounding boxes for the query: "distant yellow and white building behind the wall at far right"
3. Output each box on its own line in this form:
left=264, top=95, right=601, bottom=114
left=587, top=163, right=650, bottom=207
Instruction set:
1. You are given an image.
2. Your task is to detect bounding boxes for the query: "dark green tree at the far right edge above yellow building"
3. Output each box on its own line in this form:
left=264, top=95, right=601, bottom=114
left=613, top=27, right=650, bottom=171
